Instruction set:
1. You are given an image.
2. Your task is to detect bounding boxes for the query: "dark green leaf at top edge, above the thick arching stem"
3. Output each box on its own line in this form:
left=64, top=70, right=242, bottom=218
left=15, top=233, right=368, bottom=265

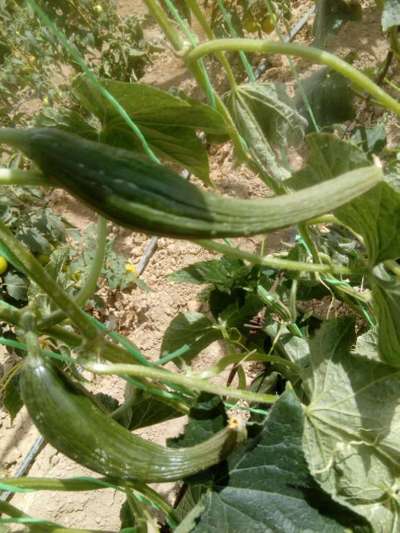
left=313, top=0, right=362, bottom=48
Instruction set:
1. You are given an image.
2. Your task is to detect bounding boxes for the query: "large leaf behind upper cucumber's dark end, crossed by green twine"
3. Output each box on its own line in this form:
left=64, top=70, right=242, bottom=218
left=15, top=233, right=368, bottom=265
left=73, top=76, right=226, bottom=180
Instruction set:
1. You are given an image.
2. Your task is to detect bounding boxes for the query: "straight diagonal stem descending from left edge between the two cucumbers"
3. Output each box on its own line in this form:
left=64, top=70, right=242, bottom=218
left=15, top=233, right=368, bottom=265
left=0, top=220, right=99, bottom=340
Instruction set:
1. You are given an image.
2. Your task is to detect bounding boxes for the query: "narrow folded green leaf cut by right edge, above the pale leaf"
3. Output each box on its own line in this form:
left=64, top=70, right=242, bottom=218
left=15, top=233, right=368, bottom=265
left=371, top=265, right=400, bottom=367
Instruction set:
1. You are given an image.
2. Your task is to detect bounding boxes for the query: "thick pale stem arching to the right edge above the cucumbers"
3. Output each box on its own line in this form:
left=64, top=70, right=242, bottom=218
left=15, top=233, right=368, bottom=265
left=186, top=39, right=400, bottom=115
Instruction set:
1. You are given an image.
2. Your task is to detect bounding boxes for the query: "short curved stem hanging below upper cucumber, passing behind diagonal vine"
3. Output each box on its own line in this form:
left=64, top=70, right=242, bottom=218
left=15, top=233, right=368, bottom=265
left=39, top=216, right=107, bottom=329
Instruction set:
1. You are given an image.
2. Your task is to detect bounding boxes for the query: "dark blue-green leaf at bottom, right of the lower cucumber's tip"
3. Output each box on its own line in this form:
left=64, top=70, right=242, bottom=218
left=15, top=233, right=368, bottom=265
left=183, top=390, right=368, bottom=533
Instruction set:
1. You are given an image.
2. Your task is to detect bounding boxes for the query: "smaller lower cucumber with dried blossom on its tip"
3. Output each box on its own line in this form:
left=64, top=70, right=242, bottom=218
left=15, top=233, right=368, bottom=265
left=21, top=354, right=244, bottom=483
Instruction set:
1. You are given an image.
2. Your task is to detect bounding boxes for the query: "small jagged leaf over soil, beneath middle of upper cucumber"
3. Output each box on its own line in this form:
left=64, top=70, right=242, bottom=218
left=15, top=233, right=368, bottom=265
left=168, top=257, right=251, bottom=293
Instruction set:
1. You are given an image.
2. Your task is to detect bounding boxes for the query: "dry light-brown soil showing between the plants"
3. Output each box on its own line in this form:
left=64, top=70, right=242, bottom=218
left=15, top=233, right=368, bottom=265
left=0, top=0, right=387, bottom=531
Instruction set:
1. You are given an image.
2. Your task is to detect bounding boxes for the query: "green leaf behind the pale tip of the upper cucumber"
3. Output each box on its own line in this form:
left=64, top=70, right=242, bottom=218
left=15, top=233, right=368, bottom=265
left=288, top=134, right=400, bottom=265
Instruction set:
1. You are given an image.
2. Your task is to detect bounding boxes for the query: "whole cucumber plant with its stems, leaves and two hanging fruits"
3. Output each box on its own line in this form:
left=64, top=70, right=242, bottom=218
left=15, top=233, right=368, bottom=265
left=0, top=0, right=400, bottom=532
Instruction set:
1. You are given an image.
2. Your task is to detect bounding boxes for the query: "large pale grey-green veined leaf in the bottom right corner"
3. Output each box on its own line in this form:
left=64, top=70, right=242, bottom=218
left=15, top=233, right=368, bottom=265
left=304, top=319, right=400, bottom=533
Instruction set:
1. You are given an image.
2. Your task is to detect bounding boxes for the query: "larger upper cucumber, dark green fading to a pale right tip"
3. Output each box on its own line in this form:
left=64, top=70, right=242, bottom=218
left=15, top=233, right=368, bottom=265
left=0, top=128, right=382, bottom=239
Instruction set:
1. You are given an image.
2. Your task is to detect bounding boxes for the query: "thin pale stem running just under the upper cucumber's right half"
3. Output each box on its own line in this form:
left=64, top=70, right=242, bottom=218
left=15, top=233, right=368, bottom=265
left=193, top=240, right=354, bottom=276
